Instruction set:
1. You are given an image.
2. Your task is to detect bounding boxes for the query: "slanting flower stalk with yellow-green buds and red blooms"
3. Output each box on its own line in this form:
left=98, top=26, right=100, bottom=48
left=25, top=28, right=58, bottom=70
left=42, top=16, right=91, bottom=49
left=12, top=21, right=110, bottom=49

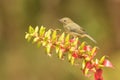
left=25, top=26, right=113, bottom=80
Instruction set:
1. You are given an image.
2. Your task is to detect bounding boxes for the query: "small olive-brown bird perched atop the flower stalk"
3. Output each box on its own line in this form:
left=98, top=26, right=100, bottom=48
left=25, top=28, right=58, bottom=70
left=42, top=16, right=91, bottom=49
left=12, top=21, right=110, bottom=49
left=59, top=17, right=97, bottom=43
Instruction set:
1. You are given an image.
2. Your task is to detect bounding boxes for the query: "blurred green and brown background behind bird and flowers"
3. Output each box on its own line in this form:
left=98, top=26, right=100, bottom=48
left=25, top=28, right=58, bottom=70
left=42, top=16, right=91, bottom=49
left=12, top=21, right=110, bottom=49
left=0, top=0, right=120, bottom=80
